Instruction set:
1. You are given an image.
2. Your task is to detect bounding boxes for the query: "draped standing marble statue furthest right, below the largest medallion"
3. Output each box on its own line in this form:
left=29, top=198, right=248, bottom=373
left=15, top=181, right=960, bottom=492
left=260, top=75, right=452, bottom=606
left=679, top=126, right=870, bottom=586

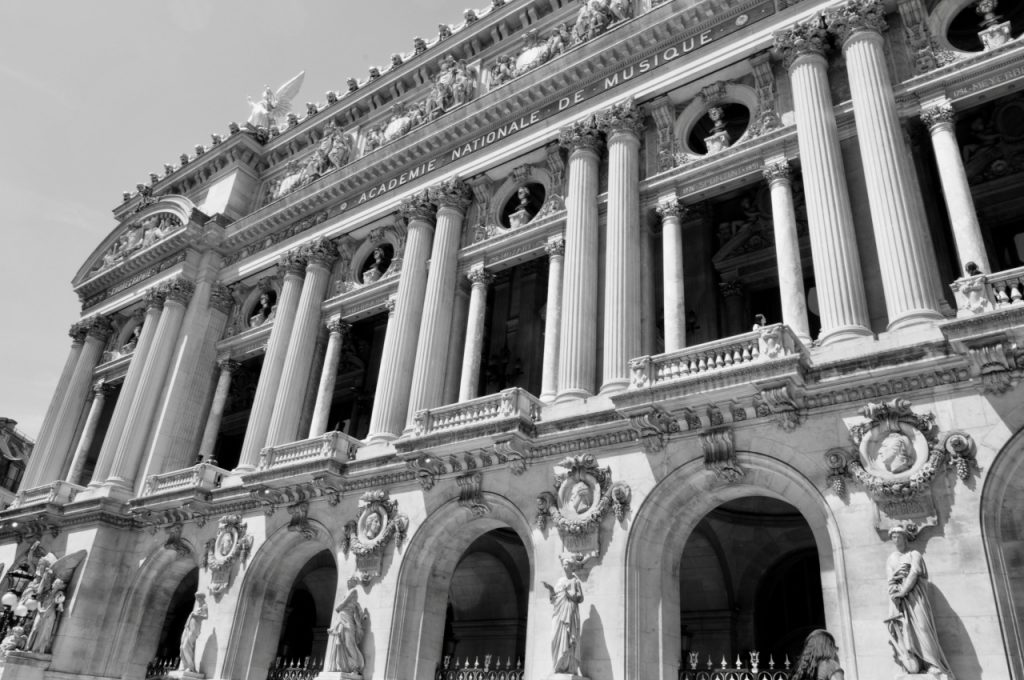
left=886, top=526, right=952, bottom=678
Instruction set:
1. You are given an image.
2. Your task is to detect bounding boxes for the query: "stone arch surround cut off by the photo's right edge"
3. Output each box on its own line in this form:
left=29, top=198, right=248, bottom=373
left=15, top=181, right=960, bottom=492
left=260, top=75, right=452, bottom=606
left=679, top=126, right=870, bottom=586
left=980, top=421, right=1024, bottom=680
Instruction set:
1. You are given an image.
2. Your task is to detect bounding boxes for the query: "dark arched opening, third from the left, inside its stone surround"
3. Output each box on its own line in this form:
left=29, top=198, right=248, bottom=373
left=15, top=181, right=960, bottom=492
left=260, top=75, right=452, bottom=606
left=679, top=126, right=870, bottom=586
left=441, top=528, right=529, bottom=667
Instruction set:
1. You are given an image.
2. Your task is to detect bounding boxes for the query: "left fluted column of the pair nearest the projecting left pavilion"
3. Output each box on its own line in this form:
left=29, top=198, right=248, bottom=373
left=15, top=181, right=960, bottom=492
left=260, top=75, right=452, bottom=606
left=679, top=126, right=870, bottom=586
left=237, top=251, right=306, bottom=470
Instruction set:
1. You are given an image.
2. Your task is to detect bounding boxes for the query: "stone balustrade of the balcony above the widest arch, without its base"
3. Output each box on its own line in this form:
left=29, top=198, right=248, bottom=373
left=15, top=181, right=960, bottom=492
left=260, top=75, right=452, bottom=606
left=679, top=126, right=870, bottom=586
left=630, top=324, right=807, bottom=390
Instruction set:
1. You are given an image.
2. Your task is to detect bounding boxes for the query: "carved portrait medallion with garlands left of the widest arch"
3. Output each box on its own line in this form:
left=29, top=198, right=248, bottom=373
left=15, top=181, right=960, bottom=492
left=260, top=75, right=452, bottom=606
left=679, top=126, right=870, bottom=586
left=538, top=454, right=632, bottom=571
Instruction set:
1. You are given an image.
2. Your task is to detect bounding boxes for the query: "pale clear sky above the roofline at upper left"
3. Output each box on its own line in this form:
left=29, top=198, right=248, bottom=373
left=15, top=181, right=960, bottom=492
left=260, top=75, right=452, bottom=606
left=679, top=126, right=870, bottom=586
left=0, top=0, right=475, bottom=437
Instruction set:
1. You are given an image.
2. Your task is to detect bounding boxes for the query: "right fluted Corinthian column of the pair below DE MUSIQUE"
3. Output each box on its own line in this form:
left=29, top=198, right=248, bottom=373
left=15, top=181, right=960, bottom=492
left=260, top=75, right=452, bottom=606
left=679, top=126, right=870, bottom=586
left=599, top=99, right=643, bottom=394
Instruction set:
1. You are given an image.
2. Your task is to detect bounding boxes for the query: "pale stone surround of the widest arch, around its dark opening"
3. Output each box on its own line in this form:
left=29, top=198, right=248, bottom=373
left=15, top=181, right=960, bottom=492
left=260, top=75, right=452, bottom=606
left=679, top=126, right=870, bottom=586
left=625, top=453, right=857, bottom=680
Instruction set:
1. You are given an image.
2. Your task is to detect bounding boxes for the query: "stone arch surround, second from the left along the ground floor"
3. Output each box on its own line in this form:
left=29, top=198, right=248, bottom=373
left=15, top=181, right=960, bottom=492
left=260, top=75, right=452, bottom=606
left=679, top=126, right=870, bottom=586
left=222, top=519, right=340, bottom=678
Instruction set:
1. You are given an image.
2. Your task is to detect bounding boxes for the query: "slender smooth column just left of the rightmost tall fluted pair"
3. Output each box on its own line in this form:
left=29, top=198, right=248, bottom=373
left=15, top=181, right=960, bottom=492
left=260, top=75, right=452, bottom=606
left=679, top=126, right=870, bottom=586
left=764, top=161, right=811, bottom=345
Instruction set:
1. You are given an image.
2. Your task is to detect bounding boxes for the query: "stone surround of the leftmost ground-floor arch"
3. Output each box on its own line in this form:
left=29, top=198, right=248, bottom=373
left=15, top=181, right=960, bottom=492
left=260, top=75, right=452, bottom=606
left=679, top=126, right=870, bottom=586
left=103, top=540, right=199, bottom=678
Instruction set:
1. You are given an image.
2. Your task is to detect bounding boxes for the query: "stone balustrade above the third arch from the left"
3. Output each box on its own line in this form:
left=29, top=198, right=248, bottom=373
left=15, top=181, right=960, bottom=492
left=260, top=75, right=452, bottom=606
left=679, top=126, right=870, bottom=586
left=413, top=387, right=543, bottom=437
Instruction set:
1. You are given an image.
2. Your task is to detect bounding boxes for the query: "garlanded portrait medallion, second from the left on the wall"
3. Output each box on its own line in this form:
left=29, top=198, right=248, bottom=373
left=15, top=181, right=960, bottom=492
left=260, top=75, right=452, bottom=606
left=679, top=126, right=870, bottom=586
left=344, top=488, right=409, bottom=584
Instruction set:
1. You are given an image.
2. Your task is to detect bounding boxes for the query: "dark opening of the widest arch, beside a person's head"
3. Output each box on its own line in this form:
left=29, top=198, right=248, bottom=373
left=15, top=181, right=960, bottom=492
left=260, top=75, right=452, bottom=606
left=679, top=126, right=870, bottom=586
left=679, top=496, right=825, bottom=665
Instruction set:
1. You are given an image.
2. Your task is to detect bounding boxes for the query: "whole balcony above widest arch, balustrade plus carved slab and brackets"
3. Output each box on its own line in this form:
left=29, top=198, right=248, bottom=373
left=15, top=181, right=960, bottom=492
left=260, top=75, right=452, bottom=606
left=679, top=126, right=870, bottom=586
left=611, top=324, right=809, bottom=421
